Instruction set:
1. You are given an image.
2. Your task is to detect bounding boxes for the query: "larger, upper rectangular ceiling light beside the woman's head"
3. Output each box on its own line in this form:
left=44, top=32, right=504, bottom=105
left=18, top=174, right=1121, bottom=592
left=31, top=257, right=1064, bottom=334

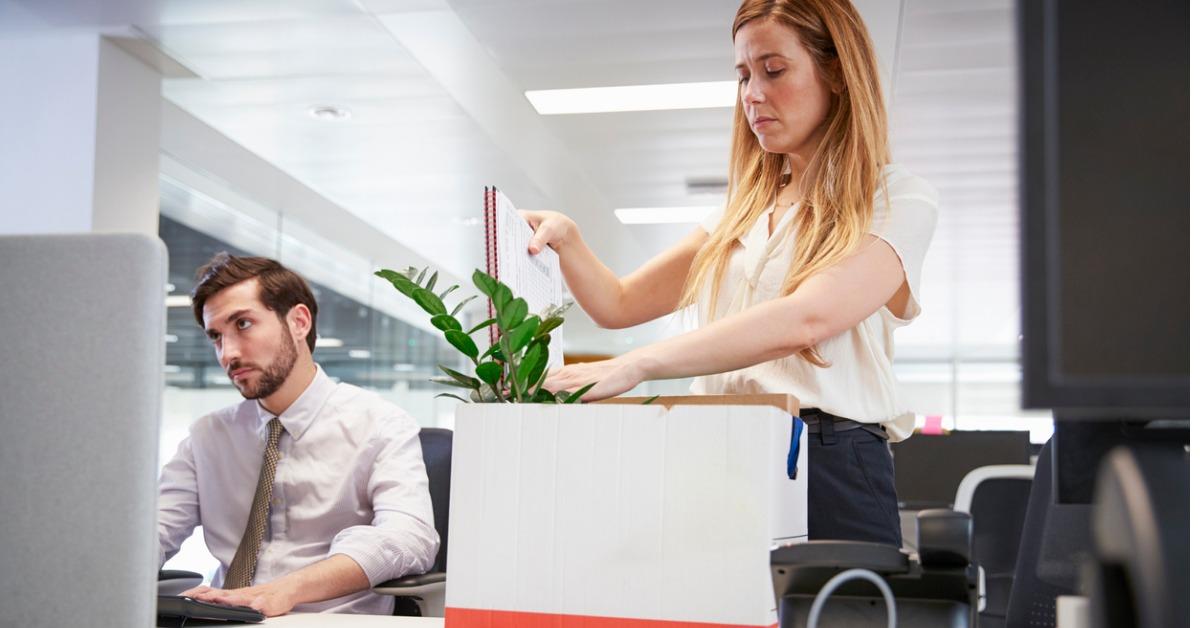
left=526, top=80, right=738, bottom=115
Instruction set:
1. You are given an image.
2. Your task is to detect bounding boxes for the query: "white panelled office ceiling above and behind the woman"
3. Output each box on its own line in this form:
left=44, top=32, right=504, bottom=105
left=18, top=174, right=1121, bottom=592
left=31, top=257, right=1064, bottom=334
left=0, top=0, right=1018, bottom=360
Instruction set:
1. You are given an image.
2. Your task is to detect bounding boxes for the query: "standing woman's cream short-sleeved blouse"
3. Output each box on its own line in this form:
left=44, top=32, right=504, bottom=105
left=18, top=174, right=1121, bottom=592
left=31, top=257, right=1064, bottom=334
left=691, top=165, right=937, bottom=442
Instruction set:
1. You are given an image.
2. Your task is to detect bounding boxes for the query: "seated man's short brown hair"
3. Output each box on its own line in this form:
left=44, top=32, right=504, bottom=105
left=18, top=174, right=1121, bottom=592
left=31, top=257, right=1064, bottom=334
left=192, top=251, right=317, bottom=352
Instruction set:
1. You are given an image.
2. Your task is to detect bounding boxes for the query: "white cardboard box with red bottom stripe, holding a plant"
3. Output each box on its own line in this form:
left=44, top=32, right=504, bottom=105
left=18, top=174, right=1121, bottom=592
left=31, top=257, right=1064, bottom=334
left=446, top=395, right=808, bottom=628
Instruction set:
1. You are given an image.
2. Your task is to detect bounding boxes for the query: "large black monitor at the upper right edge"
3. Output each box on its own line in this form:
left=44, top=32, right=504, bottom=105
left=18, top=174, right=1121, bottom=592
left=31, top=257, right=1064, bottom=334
left=1018, top=0, right=1189, bottom=419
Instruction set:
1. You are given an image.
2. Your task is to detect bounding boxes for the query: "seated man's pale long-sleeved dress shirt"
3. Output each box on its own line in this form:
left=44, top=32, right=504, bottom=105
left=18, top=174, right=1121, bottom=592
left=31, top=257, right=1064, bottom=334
left=158, top=366, right=438, bottom=615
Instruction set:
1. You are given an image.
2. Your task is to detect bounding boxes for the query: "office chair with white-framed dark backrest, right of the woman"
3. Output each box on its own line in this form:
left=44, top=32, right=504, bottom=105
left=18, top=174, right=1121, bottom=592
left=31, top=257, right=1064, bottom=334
left=954, top=465, right=1033, bottom=628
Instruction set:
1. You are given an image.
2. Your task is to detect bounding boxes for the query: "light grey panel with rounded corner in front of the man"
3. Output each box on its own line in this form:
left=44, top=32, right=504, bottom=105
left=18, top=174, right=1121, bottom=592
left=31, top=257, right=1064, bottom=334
left=0, top=234, right=167, bottom=628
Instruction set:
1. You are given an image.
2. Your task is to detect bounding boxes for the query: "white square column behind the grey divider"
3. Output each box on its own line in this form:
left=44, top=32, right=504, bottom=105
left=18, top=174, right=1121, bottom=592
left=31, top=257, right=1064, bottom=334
left=0, top=31, right=162, bottom=235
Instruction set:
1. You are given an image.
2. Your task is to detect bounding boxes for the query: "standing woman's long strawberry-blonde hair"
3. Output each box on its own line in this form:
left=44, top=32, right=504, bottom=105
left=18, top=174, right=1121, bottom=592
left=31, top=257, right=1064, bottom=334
left=680, top=0, right=889, bottom=366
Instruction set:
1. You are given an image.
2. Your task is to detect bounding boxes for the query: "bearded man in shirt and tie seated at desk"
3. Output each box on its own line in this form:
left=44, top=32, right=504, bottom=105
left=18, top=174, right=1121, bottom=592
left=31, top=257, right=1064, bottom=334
left=158, top=253, right=438, bottom=616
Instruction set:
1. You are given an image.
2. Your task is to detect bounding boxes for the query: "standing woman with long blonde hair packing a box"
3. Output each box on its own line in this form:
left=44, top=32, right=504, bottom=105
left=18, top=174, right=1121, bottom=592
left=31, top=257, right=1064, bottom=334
left=523, top=0, right=937, bottom=545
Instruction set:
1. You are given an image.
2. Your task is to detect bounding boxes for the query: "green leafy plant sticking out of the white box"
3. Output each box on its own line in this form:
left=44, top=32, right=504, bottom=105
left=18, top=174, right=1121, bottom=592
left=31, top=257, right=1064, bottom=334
left=376, top=267, right=594, bottom=403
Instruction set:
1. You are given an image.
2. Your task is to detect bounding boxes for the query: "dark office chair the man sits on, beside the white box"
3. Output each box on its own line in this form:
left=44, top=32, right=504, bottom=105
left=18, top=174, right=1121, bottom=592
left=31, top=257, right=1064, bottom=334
left=373, top=427, right=454, bottom=617
